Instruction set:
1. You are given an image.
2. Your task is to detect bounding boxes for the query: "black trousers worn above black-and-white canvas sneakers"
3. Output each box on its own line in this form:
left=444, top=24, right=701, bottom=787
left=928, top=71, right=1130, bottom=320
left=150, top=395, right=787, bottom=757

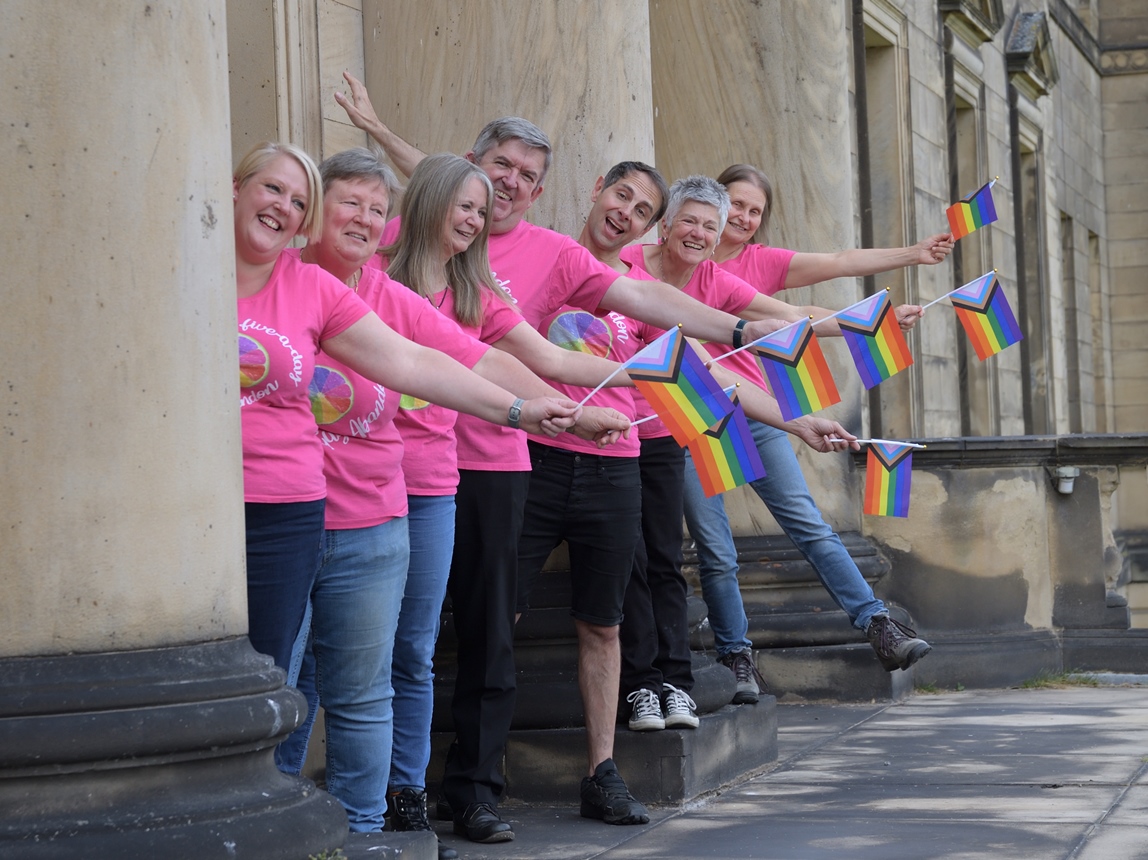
left=619, top=436, right=693, bottom=698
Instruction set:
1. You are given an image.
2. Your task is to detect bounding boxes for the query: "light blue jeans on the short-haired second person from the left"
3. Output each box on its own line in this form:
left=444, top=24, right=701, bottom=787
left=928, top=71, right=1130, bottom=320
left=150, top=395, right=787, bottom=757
left=276, top=517, right=410, bottom=832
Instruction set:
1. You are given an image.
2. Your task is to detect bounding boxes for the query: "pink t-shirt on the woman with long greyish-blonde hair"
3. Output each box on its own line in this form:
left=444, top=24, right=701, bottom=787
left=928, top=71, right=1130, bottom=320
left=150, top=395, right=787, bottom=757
left=395, top=287, right=507, bottom=496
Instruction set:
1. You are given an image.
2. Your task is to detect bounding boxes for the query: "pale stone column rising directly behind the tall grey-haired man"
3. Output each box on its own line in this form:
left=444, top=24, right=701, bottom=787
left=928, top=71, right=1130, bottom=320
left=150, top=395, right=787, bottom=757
left=362, top=0, right=653, bottom=235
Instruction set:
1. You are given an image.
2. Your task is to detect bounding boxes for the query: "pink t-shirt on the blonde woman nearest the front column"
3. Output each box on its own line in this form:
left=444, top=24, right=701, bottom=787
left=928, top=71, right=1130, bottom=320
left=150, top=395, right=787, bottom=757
left=238, top=254, right=371, bottom=503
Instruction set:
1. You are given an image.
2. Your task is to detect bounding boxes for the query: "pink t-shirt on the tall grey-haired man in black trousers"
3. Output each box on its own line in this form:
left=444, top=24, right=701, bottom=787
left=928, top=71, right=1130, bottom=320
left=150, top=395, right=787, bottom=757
left=457, top=214, right=621, bottom=472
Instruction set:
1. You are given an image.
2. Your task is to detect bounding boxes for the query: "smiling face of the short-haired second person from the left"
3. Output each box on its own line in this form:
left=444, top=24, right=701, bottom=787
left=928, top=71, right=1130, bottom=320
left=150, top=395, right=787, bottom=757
left=315, top=179, right=389, bottom=278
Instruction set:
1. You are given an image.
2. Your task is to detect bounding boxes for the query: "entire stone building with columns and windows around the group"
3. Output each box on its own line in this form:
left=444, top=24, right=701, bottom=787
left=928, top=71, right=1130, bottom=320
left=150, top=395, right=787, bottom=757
left=0, top=0, right=1148, bottom=857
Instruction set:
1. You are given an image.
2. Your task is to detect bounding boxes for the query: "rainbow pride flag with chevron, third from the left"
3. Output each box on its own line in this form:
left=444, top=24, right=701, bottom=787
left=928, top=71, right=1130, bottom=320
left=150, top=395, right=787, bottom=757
left=752, top=319, right=841, bottom=421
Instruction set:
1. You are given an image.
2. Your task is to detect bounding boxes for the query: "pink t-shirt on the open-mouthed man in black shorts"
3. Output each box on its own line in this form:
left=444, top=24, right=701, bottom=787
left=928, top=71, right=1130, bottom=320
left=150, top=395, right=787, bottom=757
left=530, top=305, right=646, bottom=457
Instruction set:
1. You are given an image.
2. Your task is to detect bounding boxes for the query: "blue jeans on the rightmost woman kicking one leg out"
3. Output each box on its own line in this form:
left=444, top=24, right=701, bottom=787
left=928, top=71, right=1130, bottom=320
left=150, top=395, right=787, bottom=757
left=685, top=420, right=886, bottom=656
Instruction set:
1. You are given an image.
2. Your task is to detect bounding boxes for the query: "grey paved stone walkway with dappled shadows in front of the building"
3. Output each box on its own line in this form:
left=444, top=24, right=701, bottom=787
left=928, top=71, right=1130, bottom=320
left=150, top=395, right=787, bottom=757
left=429, top=675, right=1148, bottom=860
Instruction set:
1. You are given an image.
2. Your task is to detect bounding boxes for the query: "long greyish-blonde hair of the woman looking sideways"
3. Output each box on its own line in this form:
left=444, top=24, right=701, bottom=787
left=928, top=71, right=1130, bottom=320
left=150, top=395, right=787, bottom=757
left=382, top=153, right=512, bottom=326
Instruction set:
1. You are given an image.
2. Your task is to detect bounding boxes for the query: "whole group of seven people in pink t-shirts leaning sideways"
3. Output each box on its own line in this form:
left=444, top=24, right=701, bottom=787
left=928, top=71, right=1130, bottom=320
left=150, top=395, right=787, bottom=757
left=233, top=75, right=952, bottom=858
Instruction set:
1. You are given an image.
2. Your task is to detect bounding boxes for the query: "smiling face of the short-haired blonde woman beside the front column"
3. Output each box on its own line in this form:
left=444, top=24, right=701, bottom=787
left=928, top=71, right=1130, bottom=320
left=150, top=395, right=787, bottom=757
left=234, top=155, right=310, bottom=264
